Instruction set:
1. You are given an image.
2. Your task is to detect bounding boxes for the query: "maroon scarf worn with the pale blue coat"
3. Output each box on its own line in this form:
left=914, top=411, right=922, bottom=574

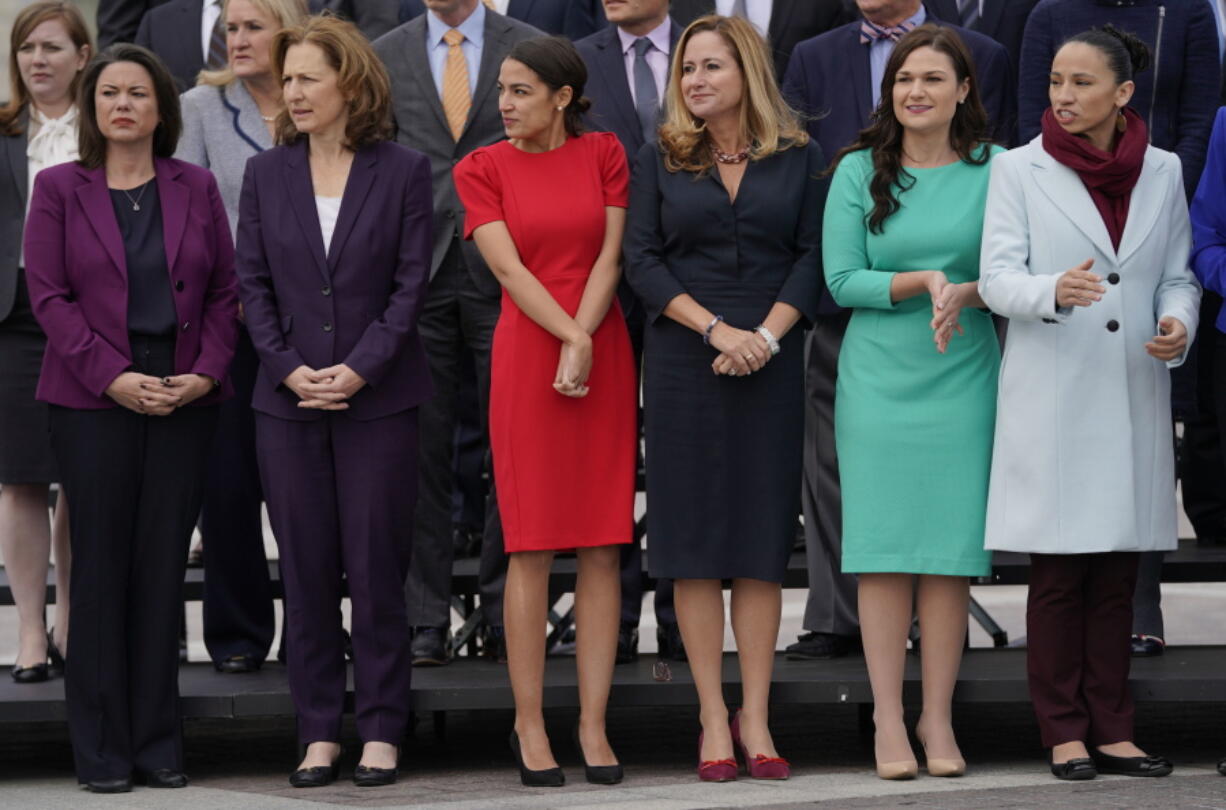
left=1043, top=107, right=1149, bottom=250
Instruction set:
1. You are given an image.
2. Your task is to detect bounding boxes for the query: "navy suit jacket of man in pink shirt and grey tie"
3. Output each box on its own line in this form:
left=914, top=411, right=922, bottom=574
left=575, top=22, right=682, bottom=160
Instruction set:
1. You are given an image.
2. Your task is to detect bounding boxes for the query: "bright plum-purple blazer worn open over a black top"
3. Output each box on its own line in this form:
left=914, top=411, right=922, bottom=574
left=25, top=158, right=238, bottom=411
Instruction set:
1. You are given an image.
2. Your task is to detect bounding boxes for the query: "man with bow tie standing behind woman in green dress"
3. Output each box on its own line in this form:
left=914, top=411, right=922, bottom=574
left=783, top=0, right=1014, bottom=658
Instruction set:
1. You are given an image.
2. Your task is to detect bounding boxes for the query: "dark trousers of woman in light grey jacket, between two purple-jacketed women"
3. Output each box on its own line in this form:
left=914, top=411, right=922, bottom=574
left=200, top=328, right=276, bottom=663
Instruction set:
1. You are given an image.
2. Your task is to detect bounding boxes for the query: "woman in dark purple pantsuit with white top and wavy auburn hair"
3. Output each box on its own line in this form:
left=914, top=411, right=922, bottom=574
left=238, top=17, right=432, bottom=788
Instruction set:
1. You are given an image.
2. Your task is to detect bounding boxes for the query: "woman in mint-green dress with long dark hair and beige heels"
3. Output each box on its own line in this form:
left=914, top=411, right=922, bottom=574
left=823, top=25, right=1000, bottom=779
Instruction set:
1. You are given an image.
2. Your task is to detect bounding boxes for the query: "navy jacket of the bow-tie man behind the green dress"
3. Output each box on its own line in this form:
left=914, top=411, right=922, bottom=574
left=783, top=10, right=1015, bottom=161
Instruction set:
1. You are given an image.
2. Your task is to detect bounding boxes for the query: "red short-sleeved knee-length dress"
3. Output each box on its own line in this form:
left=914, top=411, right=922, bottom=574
left=454, top=132, right=638, bottom=551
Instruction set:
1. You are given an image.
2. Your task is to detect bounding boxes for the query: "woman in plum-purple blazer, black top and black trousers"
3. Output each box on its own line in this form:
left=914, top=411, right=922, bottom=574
left=25, top=45, right=238, bottom=793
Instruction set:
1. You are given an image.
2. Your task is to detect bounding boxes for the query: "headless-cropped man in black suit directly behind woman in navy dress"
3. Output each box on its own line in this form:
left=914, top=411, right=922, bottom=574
left=669, top=0, right=851, bottom=78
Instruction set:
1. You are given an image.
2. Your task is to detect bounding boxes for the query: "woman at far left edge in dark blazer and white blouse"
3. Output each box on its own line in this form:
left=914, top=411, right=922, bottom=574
left=0, top=2, right=93, bottom=684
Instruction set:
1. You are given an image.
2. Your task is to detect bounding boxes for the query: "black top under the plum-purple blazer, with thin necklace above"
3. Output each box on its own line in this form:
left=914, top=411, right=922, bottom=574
left=110, top=179, right=179, bottom=336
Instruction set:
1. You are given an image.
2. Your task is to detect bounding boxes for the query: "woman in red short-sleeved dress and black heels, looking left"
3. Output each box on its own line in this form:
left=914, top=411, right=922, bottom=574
left=455, top=37, right=638, bottom=785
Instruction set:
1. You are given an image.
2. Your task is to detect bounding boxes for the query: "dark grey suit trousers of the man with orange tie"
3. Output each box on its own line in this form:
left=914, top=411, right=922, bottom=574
left=407, top=240, right=506, bottom=627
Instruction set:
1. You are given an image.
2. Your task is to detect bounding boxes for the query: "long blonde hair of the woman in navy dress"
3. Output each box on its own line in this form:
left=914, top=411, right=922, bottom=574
left=660, top=15, right=809, bottom=172
